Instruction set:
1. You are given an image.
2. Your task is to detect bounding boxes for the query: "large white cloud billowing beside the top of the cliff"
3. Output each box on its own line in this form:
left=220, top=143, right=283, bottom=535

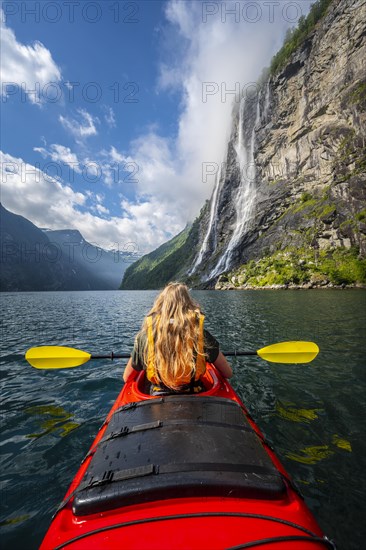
left=110, top=0, right=309, bottom=237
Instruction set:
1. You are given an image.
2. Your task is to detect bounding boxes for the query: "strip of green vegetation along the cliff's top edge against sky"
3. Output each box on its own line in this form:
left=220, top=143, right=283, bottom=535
left=270, top=0, right=333, bottom=74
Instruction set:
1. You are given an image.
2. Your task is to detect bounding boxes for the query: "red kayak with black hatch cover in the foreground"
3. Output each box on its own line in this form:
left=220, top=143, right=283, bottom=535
left=41, top=365, right=335, bottom=550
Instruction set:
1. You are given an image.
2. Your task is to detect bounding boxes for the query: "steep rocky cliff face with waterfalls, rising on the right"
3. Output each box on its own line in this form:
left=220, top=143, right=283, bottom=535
left=122, top=0, right=366, bottom=294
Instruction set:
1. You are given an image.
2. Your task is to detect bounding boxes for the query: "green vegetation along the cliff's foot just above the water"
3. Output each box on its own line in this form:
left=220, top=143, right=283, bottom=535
left=219, top=247, right=366, bottom=288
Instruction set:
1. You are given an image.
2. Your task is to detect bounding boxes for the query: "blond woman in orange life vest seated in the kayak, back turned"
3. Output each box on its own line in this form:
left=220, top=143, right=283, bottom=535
left=123, top=283, right=233, bottom=395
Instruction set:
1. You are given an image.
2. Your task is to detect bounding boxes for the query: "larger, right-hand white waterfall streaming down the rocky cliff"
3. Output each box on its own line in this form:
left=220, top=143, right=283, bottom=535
left=209, top=94, right=260, bottom=279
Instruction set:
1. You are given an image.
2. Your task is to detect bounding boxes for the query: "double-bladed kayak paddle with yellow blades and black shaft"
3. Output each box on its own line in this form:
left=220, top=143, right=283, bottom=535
left=25, top=342, right=319, bottom=369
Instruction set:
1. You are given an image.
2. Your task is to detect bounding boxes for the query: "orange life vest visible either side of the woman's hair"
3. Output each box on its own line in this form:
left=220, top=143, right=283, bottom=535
left=146, top=313, right=206, bottom=386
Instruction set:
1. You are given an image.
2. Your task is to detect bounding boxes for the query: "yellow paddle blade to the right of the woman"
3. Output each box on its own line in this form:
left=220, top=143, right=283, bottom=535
left=257, top=342, right=319, bottom=363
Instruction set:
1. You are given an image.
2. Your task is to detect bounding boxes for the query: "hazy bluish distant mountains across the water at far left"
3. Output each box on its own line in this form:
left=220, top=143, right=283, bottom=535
left=0, top=205, right=133, bottom=291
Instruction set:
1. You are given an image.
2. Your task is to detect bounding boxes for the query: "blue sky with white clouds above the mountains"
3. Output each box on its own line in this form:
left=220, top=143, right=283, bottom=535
left=1, top=0, right=309, bottom=253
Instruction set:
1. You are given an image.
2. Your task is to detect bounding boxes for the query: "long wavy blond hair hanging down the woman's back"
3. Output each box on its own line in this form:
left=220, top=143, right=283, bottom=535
left=140, top=283, right=201, bottom=390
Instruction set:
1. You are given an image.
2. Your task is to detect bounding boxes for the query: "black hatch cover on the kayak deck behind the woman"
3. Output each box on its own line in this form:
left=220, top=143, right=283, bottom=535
left=73, top=395, right=286, bottom=516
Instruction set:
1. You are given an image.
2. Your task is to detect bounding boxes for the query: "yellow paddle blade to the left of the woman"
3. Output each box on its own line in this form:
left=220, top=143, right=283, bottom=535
left=25, top=346, right=91, bottom=369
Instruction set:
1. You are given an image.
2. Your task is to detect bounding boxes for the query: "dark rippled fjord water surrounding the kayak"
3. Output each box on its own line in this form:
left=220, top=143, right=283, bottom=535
left=0, top=290, right=366, bottom=550
